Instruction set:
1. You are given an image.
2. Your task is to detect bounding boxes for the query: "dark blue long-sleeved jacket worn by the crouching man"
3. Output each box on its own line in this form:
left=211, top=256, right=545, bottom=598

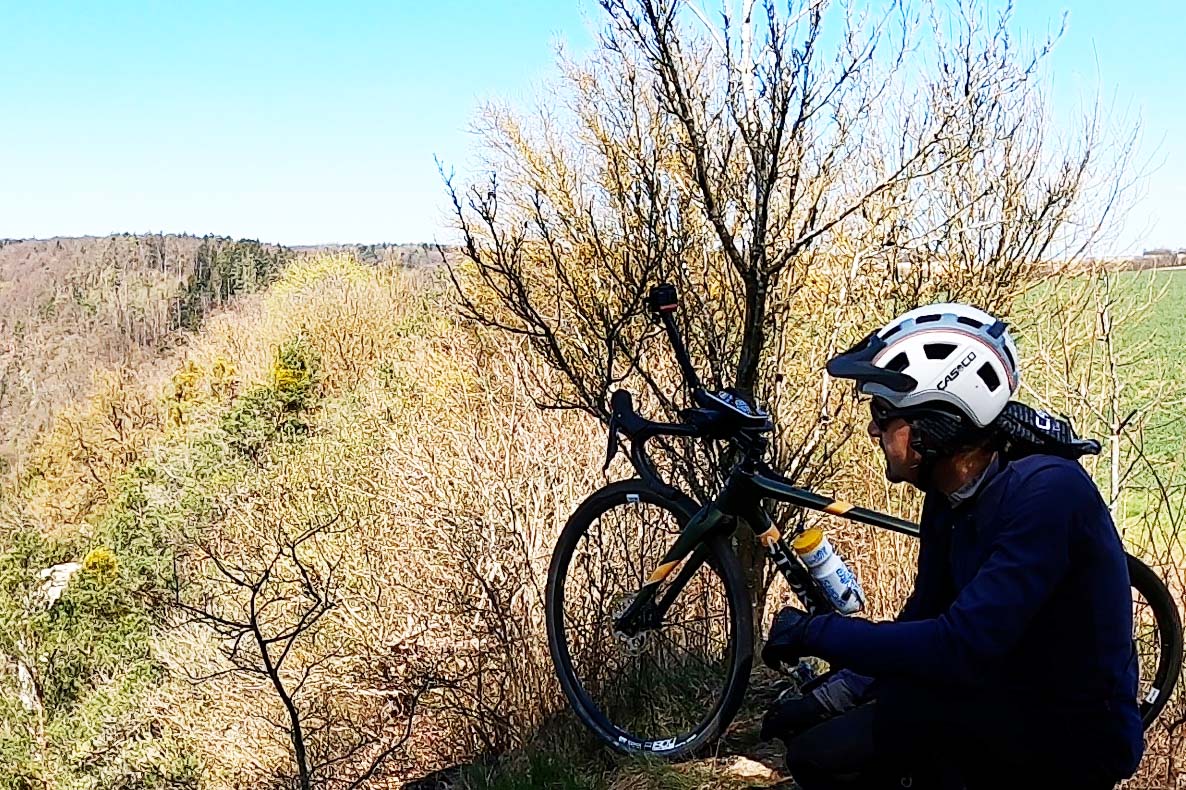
left=806, top=455, right=1143, bottom=776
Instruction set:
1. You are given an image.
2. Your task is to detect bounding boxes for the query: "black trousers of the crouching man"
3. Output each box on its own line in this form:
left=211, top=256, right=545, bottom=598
left=786, top=684, right=1117, bottom=790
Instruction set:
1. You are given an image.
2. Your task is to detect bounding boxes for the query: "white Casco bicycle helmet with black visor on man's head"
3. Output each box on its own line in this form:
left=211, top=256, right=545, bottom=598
left=828, top=302, right=1021, bottom=428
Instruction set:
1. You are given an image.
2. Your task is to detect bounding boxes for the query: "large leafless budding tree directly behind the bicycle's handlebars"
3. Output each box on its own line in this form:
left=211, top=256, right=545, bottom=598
left=442, top=0, right=1130, bottom=607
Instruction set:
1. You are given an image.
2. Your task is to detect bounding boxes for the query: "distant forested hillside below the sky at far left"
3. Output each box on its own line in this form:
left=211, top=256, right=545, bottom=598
left=0, top=234, right=441, bottom=472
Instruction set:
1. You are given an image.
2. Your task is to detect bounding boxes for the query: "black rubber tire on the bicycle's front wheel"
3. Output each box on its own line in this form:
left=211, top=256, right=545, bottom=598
left=546, top=479, right=753, bottom=759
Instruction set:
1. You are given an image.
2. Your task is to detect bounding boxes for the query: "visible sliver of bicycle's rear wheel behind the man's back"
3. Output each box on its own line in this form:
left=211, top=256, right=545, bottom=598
left=1128, top=555, right=1182, bottom=730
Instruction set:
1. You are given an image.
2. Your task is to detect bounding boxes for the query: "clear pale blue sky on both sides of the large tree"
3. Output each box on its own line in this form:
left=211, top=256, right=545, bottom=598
left=0, top=0, right=1186, bottom=251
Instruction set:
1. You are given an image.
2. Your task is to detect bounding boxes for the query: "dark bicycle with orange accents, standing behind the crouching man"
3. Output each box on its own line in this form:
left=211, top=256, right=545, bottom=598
left=546, top=286, right=1182, bottom=759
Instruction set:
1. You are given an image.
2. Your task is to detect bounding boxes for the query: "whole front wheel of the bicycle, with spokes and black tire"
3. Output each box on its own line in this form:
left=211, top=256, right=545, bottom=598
left=547, top=480, right=753, bottom=759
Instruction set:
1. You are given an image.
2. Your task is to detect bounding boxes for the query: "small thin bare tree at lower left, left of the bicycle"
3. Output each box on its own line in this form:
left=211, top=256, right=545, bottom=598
left=176, top=510, right=415, bottom=790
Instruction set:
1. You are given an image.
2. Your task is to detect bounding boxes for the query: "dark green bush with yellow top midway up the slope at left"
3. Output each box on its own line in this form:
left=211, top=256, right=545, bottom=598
left=222, top=336, right=320, bottom=459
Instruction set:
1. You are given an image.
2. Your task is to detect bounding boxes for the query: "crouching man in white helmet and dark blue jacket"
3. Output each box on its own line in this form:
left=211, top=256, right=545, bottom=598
left=763, top=304, right=1143, bottom=790
